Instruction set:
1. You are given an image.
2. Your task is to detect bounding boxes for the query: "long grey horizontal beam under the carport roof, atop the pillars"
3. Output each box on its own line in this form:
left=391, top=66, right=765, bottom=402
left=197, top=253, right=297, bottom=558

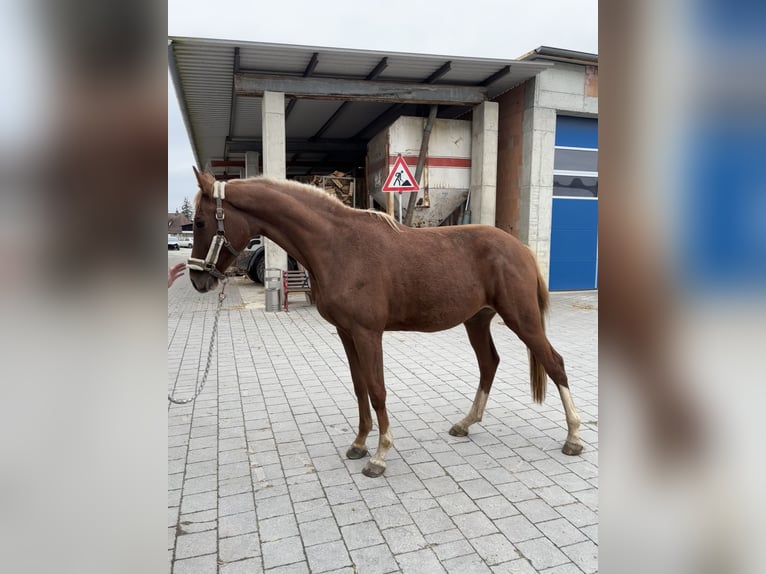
left=234, top=73, right=487, bottom=105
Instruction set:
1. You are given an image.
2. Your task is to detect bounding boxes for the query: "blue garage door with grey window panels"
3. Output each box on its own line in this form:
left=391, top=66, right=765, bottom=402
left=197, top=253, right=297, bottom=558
left=548, top=116, right=598, bottom=291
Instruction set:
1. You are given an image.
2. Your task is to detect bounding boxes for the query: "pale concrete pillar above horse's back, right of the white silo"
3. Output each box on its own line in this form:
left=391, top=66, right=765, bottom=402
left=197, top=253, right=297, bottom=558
left=471, top=102, right=498, bottom=225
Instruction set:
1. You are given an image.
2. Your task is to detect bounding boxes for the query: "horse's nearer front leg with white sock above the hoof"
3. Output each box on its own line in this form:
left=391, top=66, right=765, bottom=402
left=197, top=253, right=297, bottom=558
left=353, top=331, right=394, bottom=478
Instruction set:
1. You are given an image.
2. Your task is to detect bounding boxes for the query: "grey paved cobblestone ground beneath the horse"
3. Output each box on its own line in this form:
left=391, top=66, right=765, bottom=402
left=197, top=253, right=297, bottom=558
left=168, top=250, right=598, bottom=574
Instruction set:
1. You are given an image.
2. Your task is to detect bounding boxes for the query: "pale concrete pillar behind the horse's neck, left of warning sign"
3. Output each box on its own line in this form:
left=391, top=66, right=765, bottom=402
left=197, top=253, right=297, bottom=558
left=262, top=92, right=287, bottom=269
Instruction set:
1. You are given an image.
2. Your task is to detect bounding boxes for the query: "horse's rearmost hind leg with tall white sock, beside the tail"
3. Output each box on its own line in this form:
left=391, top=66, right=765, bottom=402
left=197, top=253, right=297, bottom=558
left=500, top=307, right=582, bottom=456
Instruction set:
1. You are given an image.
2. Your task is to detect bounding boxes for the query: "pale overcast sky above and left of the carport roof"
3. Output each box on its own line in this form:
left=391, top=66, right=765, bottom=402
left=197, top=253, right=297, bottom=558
left=168, top=0, right=598, bottom=211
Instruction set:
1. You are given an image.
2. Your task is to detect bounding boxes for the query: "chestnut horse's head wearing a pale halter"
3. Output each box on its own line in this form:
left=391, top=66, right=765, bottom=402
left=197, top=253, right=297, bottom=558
left=187, top=168, right=250, bottom=293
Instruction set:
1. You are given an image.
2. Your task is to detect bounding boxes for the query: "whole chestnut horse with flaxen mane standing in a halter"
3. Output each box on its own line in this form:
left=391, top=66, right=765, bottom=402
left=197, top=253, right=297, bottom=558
left=188, top=169, right=582, bottom=477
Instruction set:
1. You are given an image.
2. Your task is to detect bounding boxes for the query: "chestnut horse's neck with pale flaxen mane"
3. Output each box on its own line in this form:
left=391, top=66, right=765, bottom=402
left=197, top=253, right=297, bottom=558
left=227, top=180, right=337, bottom=273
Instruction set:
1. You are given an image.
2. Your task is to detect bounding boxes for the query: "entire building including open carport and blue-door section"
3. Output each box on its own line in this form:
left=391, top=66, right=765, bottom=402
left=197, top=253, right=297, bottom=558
left=168, top=38, right=598, bottom=289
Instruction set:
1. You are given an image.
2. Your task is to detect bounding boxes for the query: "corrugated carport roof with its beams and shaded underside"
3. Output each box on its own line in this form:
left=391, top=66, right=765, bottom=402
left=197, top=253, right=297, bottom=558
left=168, top=37, right=552, bottom=177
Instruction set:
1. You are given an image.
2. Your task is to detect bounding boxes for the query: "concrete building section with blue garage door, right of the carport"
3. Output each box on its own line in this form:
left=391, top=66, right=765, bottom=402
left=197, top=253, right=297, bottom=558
left=496, top=47, right=598, bottom=290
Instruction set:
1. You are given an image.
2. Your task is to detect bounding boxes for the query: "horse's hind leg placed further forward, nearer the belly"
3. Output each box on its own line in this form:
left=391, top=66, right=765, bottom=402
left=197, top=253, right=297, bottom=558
left=449, top=309, right=500, bottom=436
